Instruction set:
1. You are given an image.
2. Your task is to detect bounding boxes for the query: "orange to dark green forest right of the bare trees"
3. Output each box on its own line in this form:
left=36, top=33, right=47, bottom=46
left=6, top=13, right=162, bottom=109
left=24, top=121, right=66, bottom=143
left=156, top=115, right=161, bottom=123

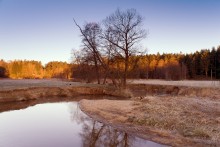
left=140, top=46, right=220, bottom=80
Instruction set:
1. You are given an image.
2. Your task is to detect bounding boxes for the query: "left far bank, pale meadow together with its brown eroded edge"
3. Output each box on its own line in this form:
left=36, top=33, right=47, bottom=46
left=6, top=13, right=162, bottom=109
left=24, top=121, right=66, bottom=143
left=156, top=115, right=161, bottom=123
left=0, top=80, right=131, bottom=102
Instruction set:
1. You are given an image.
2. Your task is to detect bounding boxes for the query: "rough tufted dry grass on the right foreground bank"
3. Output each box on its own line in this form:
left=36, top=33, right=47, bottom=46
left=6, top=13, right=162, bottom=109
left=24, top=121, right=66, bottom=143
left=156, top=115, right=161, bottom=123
left=128, top=96, right=220, bottom=142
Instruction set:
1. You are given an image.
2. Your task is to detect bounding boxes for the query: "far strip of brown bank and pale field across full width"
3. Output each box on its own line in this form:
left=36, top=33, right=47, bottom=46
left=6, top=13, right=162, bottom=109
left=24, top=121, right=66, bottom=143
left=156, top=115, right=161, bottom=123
left=0, top=79, right=220, bottom=102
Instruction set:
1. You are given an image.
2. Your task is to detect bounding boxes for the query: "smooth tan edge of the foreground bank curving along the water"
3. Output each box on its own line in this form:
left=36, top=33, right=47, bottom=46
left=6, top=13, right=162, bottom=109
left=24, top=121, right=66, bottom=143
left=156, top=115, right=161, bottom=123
left=79, top=100, right=220, bottom=147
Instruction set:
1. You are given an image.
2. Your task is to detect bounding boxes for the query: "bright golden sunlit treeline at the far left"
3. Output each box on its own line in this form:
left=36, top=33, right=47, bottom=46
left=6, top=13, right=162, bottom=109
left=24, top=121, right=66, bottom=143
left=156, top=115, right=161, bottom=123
left=0, top=60, right=71, bottom=79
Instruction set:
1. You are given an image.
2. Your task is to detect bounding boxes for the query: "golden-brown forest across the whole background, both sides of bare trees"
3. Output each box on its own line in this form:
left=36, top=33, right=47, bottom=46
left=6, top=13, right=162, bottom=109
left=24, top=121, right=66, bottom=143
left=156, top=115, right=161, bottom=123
left=0, top=46, right=220, bottom=82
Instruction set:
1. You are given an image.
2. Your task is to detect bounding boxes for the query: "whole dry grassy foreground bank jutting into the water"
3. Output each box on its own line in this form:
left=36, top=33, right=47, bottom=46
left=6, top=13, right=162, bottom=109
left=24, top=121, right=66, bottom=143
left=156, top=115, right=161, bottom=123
left=80, top=96, right=220, bottom=146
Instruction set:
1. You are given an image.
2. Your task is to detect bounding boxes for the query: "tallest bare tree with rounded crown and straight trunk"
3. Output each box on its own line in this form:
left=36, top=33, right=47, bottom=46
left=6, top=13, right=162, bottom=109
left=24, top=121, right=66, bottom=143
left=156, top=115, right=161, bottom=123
left=102, top=9, right=146, bottom=87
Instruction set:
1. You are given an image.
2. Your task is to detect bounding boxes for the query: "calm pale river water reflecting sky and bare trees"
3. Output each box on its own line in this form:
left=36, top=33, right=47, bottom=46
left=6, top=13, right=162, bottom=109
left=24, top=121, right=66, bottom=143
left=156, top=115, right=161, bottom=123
left=0, top=102, right=167, bottom=147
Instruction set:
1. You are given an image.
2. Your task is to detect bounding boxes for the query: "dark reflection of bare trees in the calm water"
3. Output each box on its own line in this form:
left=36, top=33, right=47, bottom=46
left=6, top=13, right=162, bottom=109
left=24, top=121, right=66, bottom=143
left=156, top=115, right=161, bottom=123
left=70, top=105, right=135, bottom=147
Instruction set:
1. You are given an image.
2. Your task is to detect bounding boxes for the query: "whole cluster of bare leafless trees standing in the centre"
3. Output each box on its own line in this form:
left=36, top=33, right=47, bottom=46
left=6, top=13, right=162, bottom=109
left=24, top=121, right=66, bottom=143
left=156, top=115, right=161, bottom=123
left=74, top=9, right=146, bottom=87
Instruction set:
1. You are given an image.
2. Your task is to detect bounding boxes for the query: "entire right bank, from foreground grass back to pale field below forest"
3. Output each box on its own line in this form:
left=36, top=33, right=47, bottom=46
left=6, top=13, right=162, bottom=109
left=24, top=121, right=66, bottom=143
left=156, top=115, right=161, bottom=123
left=80, top=80, right=220, bottom=146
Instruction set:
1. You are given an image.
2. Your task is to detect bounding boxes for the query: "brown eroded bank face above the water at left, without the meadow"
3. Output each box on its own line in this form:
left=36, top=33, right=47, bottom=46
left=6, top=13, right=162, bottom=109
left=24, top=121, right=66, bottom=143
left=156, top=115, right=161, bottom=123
left=0, top=85, right=130, bottom=102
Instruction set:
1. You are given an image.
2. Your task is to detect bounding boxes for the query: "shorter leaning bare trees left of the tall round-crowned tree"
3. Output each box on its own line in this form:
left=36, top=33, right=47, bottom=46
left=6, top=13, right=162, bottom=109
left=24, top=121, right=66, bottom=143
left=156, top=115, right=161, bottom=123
left=74, top=20, right=122, bottom=86
